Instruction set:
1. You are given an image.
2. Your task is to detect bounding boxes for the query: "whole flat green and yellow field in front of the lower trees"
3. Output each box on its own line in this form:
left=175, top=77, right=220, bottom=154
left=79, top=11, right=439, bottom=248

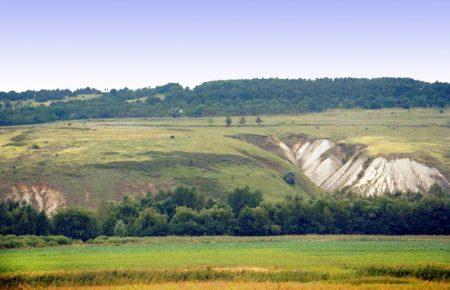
left=0, top=235, right=450, bottom=289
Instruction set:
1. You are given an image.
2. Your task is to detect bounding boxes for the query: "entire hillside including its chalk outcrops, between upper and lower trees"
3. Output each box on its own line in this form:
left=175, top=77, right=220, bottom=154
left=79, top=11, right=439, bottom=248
left=0, top=109, right=450, bottom=211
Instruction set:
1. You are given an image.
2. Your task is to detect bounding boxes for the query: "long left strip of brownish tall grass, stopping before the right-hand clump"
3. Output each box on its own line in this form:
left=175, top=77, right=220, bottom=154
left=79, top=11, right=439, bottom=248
left=0, top=269, right=329, bottom=288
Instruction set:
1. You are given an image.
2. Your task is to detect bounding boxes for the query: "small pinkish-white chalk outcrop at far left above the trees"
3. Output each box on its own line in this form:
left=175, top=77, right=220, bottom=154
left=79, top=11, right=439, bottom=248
left=5, top=184, right=66, bottom=215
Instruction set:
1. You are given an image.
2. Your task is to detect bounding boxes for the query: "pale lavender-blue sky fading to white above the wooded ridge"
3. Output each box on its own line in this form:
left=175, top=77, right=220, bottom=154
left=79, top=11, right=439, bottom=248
left=0, top=0, right=450, bottom=91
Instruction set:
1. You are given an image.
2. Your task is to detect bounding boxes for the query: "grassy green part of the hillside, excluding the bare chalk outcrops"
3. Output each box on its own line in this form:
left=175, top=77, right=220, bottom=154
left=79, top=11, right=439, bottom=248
left=0, top=109, right=450, bottom=206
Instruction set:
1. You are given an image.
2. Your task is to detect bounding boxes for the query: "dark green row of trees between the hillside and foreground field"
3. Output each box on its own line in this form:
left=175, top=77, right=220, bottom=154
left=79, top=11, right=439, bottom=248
left=0, top=187, right=450, bottom=241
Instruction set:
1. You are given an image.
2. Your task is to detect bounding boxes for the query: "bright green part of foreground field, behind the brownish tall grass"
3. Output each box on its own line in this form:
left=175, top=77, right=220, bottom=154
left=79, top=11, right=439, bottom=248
left=0, top=235, right=450, bottom=284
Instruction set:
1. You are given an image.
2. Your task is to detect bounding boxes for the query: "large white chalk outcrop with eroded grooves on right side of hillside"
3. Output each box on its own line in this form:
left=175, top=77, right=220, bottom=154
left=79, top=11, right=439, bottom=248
left=273, top=136, right=449, bottom=196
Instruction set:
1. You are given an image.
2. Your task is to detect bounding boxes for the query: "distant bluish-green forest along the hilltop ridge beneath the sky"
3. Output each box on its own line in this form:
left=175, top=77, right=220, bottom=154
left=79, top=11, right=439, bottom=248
left=0, top=78, right=450, bottom=125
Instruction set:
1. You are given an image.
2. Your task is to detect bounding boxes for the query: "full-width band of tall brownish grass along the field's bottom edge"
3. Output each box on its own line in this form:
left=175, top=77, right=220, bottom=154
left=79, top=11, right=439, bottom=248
left=0, top=266, right=450, bottom=288
